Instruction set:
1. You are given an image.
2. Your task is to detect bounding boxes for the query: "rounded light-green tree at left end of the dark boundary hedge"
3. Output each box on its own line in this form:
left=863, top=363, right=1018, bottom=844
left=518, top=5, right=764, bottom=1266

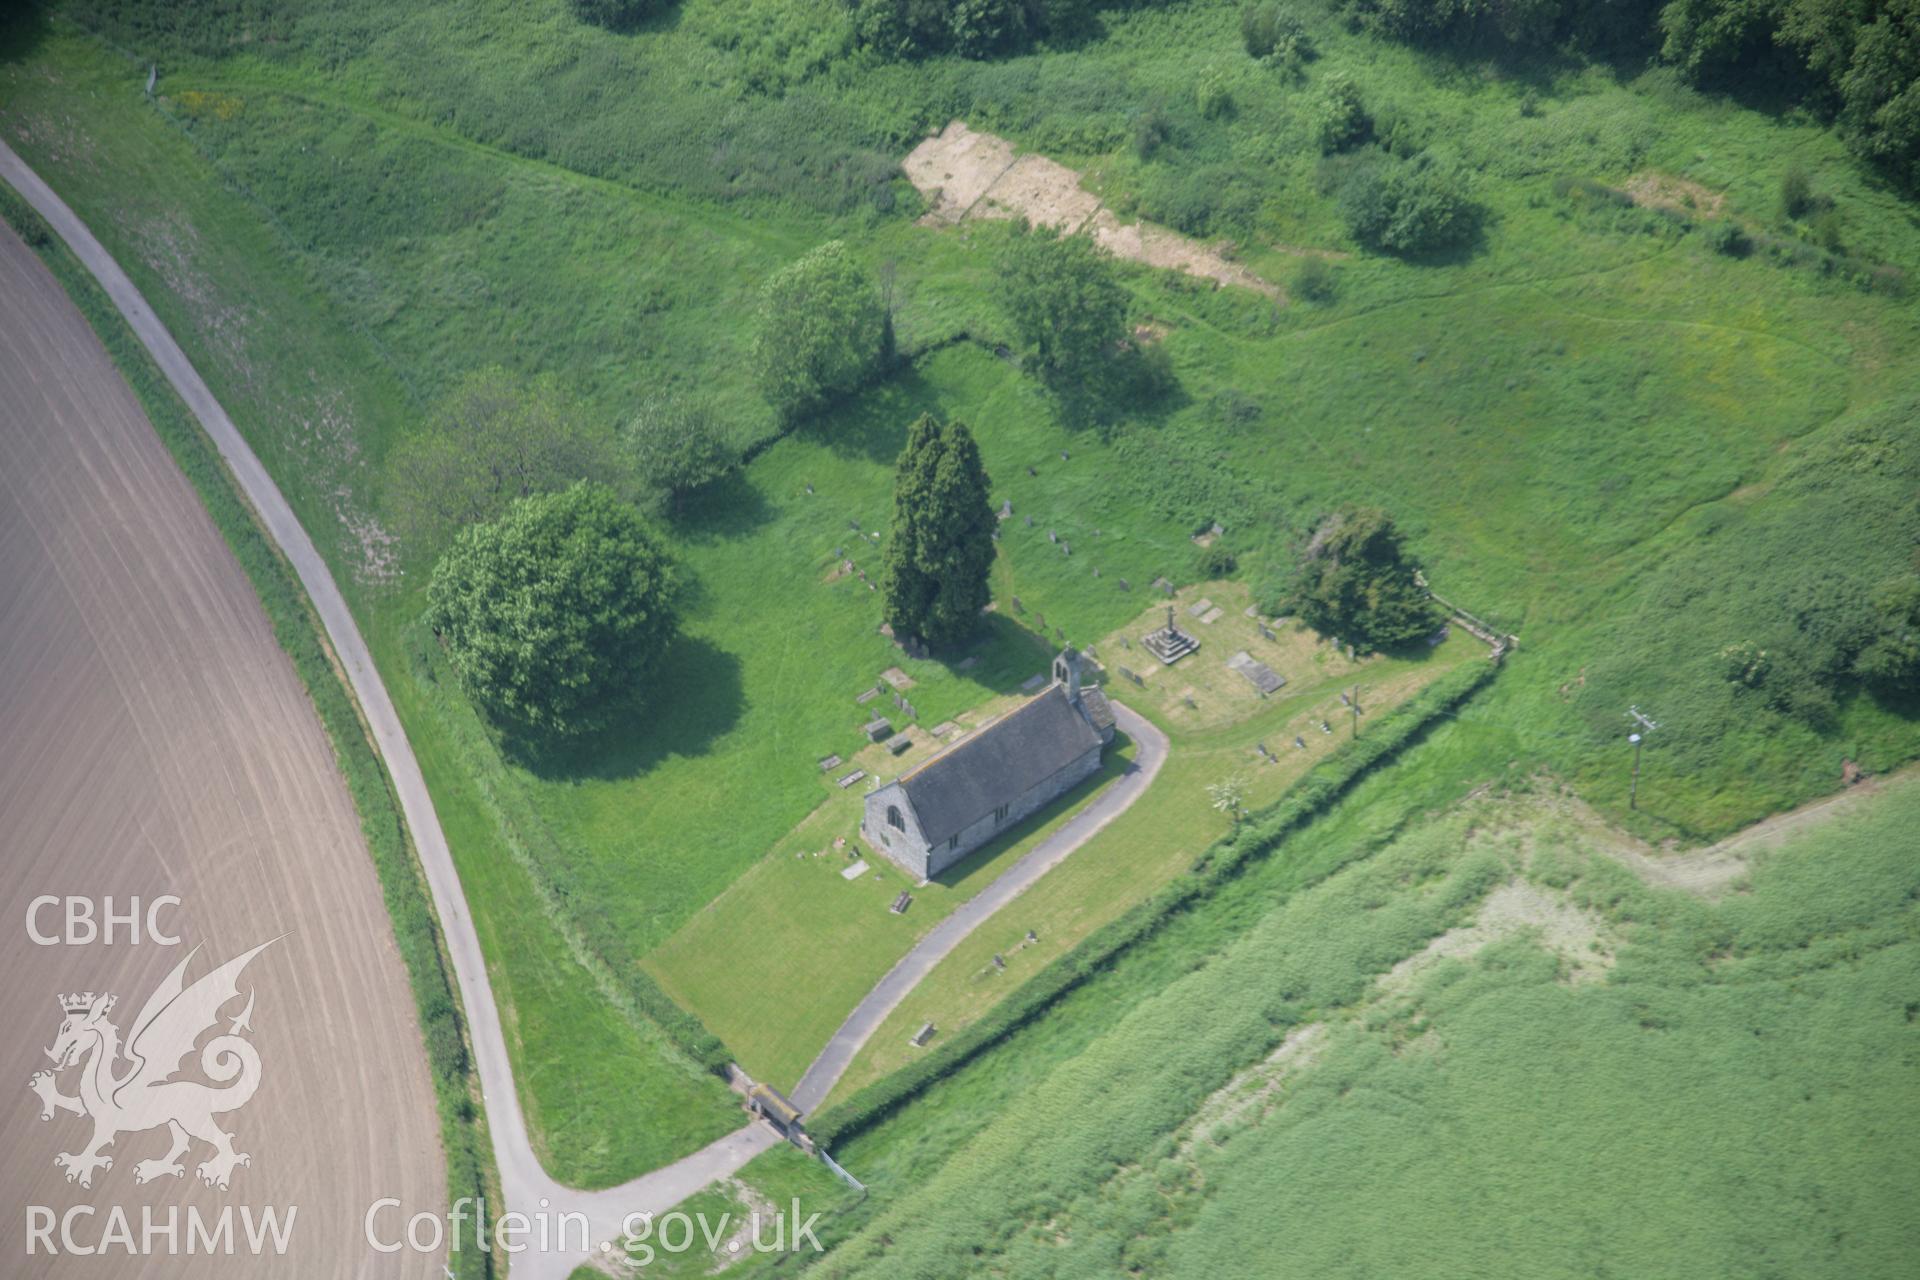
left=753, top=240, right=893, bottom=422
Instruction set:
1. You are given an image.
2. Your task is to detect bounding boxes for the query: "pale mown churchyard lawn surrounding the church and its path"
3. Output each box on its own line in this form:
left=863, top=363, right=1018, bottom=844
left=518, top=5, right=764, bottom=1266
left=643, top=581, right=1488, bottom=1096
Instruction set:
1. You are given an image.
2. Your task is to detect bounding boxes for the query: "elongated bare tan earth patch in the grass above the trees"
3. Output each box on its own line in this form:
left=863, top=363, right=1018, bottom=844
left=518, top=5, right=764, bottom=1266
left=900, top=121, right=1284, bottom=299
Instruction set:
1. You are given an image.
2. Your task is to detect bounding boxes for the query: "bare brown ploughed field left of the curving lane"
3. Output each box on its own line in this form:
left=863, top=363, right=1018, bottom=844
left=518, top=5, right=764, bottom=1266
left=0, top=226, right=445, bottom=1280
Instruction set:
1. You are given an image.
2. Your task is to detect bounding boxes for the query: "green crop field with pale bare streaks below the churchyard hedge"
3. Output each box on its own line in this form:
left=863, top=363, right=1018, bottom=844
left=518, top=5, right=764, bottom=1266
left=826, top=781, right=1920, bottom=1276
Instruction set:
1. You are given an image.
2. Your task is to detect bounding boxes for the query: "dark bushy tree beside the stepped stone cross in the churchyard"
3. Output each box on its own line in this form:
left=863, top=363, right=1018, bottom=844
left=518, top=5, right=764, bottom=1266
left=1286, top=507, right=1440, bottom=651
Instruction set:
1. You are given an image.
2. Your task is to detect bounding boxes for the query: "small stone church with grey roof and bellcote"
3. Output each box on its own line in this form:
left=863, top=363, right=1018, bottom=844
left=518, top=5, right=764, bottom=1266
left=860, top=649, right=1114, bottom=881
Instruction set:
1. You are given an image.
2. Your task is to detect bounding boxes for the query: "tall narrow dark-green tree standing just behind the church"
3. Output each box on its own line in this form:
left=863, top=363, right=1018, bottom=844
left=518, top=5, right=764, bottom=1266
left=885, top=415, right=995, bottom=645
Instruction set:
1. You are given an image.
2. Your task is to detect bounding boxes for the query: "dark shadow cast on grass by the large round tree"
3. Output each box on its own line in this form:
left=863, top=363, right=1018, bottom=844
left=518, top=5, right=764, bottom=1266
left=501, top=635, right=747, bottom=781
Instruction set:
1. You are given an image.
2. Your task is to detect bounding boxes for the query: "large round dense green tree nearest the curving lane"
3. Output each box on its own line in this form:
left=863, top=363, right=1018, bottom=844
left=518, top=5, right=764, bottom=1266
left=426, top=484, right=678, bottom=737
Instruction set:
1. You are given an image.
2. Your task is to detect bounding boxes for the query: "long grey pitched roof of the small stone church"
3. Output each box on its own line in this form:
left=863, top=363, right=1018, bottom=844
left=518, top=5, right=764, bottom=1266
left=900, top=685, right=1100, bottom=844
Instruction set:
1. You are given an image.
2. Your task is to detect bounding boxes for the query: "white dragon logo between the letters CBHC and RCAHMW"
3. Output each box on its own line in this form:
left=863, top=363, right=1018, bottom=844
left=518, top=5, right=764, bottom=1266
left=27, top=938, right=278, bottom=1190
